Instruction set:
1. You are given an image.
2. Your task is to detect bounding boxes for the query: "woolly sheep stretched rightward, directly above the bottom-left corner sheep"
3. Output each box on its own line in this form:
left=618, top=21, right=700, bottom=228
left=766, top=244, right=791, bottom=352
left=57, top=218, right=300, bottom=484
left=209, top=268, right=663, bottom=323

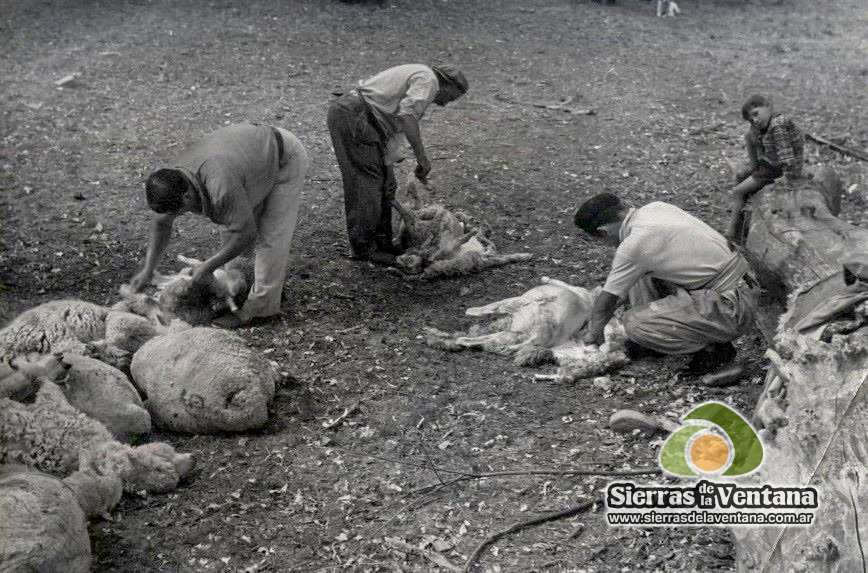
left=0, top=378, right=193, bottom=492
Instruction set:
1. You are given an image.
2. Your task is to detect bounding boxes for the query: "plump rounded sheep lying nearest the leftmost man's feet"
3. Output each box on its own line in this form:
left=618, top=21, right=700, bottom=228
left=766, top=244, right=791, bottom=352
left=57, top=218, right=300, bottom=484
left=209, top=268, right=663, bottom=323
left=132, top=328, right=280, bottom=433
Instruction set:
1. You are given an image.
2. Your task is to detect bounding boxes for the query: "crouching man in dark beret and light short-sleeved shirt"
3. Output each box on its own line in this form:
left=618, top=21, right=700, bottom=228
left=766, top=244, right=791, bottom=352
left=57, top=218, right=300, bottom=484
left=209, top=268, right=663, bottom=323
left=575, top=193, right=758, bottom=375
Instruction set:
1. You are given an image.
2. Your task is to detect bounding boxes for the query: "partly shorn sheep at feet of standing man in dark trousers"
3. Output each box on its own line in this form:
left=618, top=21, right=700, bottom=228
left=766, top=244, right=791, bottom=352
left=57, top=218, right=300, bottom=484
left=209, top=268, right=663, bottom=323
left=392, top=180, right=532, bottom=279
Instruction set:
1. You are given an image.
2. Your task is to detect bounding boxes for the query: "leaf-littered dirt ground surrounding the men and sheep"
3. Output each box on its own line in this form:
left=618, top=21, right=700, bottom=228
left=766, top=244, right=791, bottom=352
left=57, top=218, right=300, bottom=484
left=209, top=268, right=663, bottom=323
left=0, top=0, right=868, bottom=573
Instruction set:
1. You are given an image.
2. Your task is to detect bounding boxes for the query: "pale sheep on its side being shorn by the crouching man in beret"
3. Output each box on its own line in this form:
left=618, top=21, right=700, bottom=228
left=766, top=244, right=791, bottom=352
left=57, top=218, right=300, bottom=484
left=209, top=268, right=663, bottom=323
left=425, top=277, right=626, bottom=373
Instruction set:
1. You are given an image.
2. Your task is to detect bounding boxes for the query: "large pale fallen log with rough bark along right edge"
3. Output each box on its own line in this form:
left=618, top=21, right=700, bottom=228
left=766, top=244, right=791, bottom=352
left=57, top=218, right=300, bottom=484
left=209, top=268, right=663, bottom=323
left=733, top=166, right=868, bottom=573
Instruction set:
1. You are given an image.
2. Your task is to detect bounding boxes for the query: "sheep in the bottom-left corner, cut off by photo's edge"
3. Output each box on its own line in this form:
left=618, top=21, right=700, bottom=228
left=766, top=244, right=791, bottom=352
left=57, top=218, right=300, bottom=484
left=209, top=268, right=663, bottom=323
left=0, top=466, right=121, bottom=573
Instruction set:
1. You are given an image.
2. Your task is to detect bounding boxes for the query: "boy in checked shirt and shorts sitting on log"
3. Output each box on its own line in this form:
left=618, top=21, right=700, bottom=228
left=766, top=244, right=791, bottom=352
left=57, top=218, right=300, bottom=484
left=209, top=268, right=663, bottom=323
left=726, top=95, right=805, bottom=243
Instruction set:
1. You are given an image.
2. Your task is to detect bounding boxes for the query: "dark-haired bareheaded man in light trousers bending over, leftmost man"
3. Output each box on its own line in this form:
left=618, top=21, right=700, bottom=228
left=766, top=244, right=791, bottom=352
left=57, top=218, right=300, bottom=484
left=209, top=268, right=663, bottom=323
left=130, top=124, right=308, bottom=328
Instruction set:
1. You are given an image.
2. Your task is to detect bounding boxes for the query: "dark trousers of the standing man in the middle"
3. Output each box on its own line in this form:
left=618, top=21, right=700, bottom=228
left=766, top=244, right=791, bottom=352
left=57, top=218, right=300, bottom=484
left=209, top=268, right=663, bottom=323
left=328, top=94, right=397, bottom=259
